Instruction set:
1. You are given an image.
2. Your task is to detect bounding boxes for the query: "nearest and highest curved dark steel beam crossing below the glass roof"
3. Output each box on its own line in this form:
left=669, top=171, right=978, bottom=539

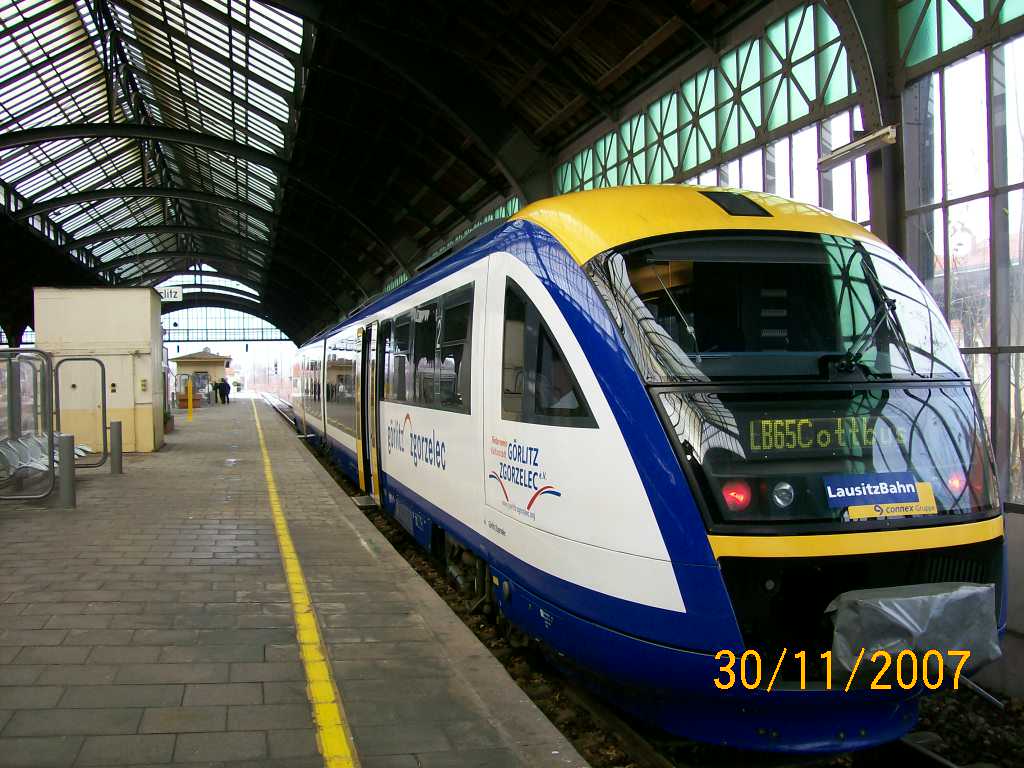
left=0, top=123, right=288, bottom=176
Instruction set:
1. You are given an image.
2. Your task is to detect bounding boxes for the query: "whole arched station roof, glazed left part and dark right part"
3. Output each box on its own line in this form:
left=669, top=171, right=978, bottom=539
left=0, top=0, right=764, bottom=341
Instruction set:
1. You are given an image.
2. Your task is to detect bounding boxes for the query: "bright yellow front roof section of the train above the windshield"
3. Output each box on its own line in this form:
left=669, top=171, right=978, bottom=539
left=512, top=184, right=881, bottom=264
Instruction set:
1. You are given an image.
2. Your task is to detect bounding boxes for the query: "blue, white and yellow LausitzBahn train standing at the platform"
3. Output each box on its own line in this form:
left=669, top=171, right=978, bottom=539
left=284, top=184, right=1007, bottom=753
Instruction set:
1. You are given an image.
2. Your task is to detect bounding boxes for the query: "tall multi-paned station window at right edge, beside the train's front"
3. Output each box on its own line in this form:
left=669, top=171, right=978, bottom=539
left=902, top=34, right=1024, bottom=509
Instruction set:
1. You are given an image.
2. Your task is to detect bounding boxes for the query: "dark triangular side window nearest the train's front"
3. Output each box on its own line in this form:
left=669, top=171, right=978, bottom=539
left=502, top=280, right=597, bottom=427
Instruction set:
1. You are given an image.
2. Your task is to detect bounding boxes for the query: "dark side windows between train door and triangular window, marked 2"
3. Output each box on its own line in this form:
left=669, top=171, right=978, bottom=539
left=381, top=285, right=473, bottom=413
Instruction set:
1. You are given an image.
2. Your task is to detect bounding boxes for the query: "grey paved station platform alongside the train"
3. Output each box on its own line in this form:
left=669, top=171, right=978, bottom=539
left=0, top=397, right=586, bottom=768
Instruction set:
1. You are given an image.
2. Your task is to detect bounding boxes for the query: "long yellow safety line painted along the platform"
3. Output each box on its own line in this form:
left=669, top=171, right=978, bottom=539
left=253, top=399, right=359, bottom=768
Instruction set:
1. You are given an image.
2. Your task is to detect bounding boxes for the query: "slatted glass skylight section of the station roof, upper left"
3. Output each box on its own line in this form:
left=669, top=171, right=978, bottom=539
left=0, top=0, right=309, bottom=291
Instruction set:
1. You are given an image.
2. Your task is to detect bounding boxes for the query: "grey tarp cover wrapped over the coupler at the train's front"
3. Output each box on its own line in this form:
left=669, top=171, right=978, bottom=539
left=825, top=582, right=1002, bottom=677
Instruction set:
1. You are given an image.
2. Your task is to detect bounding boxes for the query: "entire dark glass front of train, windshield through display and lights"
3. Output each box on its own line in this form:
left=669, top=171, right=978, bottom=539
left=588, top=232, right=998, bottom=532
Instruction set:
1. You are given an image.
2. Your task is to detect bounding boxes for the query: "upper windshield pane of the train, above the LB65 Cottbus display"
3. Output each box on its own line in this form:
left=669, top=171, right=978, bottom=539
left=588, top=232, right=967, bottom=383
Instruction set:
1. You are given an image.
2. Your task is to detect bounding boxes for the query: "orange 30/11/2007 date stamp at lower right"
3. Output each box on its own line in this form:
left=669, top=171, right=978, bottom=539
left=714, top=648, right=971, bottom=692
